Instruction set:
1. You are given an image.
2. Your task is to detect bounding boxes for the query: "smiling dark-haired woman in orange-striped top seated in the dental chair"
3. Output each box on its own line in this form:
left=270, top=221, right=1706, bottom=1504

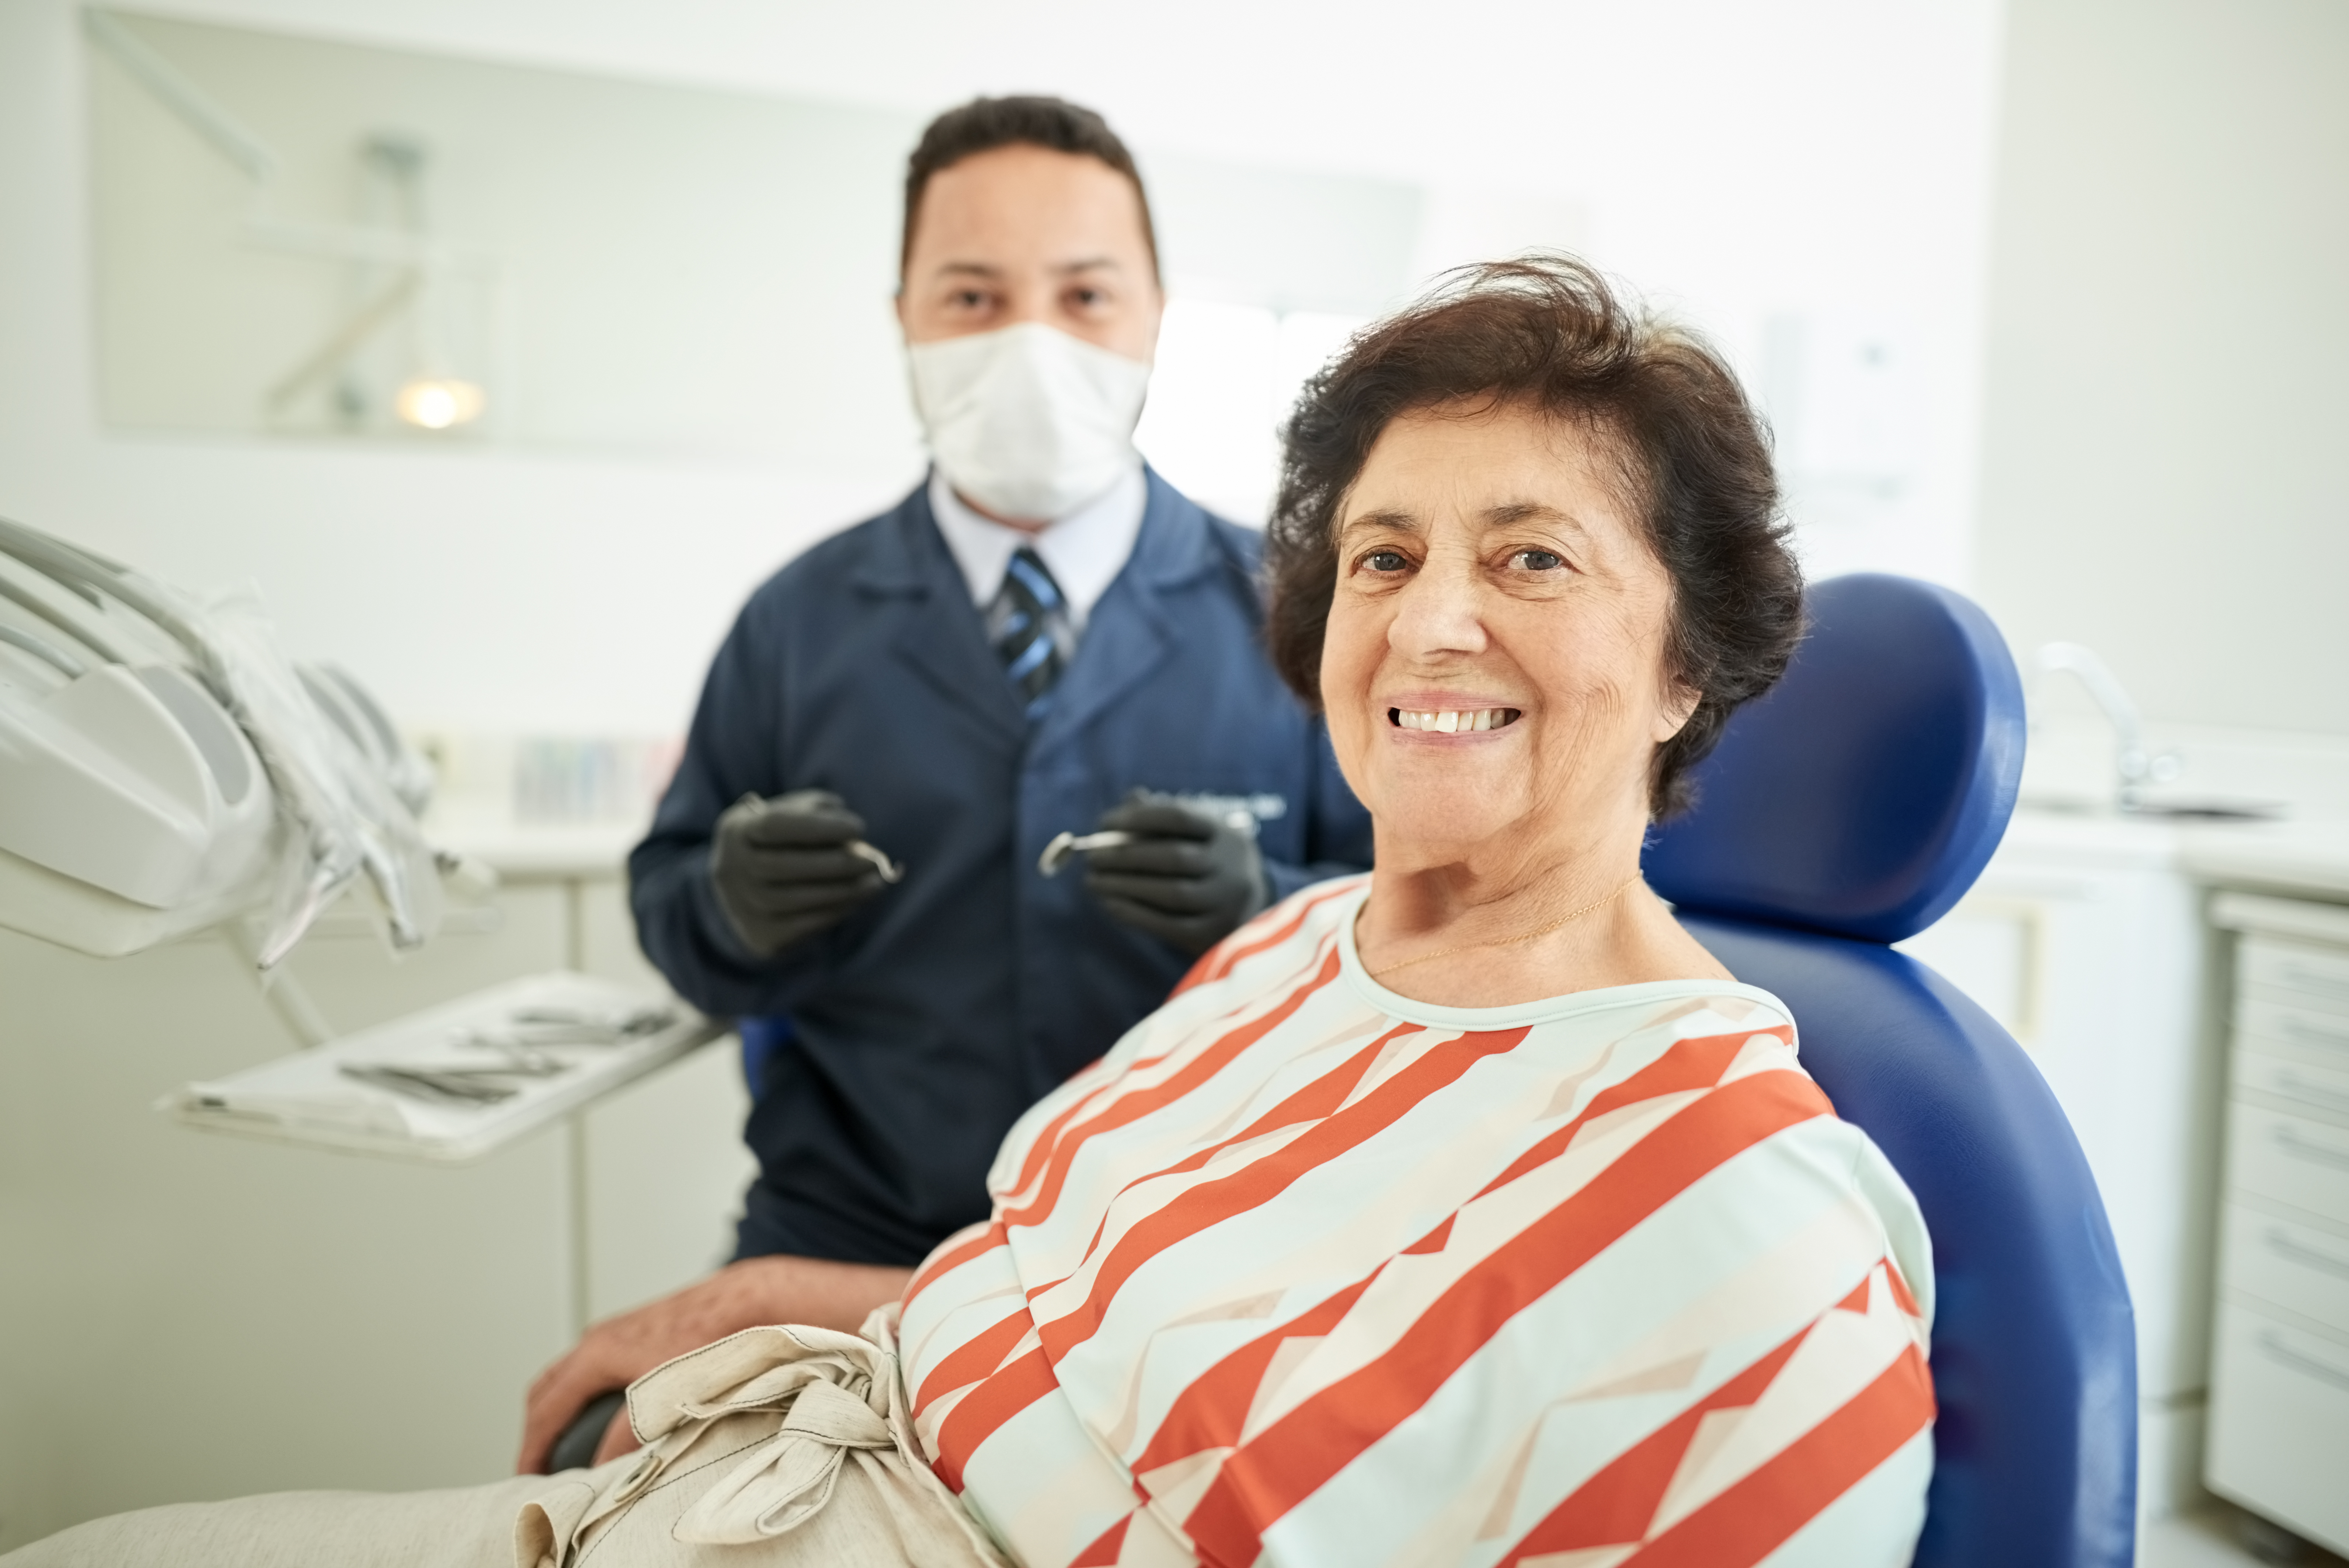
left=9, top=261, right=1933, bottom=1568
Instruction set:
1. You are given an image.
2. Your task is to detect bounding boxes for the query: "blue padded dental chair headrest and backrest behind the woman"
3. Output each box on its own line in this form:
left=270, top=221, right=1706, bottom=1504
left=1644, top=576, right=2138, bottom=1568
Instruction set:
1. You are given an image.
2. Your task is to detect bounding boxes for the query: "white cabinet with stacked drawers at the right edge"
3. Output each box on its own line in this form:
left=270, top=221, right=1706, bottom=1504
left=2208, top=893, right=2349, bottom=1551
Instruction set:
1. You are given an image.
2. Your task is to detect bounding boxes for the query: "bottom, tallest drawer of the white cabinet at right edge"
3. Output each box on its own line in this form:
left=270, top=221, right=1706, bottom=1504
left=2203, top=1302, right=2349, bottom=1551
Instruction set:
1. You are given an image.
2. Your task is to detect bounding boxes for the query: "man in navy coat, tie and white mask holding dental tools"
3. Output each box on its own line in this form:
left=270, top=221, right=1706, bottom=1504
left=519, top=99, right=1370, bottom=1472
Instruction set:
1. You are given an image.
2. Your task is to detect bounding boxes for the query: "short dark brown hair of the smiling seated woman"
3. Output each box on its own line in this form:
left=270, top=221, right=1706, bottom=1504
left=1264, top=256, right=1802, bottom=818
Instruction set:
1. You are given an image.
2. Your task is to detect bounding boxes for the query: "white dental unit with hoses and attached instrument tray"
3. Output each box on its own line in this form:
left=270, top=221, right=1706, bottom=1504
left=0, top=519, right=723, bottom=1161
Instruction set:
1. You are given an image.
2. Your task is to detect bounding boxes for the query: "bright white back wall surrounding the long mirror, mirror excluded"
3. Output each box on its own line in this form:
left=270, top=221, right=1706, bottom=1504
left=0, top=0, right=1999, bottom=733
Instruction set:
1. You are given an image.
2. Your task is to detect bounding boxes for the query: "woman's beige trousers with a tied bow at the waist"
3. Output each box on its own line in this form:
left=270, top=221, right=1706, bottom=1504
left=0, top=1305, right=1005, bottom=1568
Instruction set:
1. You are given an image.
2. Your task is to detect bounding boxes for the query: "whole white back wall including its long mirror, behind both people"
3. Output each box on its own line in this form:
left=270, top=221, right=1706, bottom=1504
left=0, top=0, right=2011, bottom=733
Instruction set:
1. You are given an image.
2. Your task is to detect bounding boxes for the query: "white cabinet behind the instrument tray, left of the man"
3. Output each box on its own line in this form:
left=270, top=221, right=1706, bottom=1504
left=0, top=870, right=749, bottom=1551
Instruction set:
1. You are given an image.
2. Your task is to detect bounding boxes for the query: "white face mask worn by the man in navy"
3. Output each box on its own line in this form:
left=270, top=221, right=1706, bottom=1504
left=907, top=322, right=1151, bottom=522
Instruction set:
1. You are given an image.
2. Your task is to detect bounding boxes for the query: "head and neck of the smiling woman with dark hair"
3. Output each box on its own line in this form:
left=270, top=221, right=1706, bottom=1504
left=1269, top=258, right=1802, bottom=1004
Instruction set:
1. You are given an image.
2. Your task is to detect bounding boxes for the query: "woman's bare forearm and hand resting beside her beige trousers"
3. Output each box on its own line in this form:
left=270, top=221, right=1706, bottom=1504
left=514, top=1255, right=914, bottom=1476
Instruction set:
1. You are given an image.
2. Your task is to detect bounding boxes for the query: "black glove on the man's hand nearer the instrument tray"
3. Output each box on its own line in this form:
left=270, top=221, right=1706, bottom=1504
left=709, top=790, right=885, bottom=957
